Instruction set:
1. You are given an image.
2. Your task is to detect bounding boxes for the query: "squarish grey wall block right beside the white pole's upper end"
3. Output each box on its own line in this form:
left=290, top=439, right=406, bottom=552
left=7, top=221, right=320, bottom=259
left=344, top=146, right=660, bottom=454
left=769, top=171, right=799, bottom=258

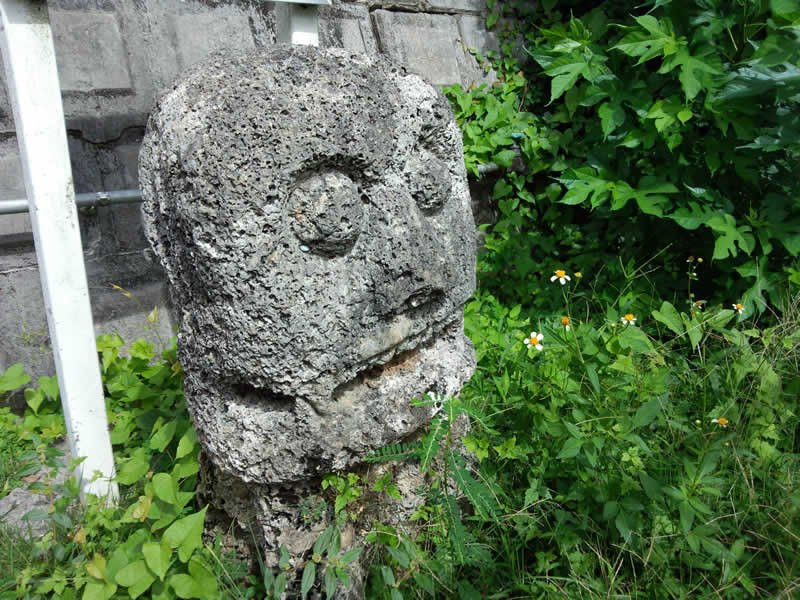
left=50, top=9, right=132, bottom=92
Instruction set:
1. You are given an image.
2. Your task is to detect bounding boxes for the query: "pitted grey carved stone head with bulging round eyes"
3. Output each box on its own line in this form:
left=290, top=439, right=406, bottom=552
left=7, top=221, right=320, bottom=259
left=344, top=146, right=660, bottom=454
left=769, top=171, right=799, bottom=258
left=140, top=46, right=475, bottom=483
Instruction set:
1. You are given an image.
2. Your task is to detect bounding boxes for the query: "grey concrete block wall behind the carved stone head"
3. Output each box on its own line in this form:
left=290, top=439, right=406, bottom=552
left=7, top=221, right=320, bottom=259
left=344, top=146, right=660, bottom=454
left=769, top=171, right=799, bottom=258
left=0, top=0, right=495, bottom=374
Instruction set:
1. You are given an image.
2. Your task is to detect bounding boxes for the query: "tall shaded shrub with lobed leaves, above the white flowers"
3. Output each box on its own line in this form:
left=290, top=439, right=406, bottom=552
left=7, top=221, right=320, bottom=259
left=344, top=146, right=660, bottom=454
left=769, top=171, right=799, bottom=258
left=447, top=0, right=800, bottom=314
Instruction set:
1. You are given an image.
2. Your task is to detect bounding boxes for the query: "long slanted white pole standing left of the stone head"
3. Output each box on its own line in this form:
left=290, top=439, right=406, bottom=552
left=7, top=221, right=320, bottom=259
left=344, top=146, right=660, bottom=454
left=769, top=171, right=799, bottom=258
left=0, top=0, right=117, bottom=500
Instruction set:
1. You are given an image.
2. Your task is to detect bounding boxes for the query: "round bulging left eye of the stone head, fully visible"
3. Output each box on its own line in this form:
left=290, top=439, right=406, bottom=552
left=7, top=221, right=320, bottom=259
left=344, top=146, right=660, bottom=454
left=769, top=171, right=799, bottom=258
left=289, top=173, right=364, bottom=256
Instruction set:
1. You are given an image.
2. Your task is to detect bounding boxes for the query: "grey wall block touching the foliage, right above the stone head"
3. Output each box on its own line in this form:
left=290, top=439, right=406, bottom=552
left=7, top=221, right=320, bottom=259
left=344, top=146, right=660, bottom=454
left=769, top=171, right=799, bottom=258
left=372, top=10, right=485, bottom=86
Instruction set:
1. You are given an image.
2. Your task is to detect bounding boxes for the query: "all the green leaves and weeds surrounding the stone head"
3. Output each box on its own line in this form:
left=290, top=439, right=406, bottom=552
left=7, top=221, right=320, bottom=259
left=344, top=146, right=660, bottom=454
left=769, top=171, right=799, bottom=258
left=0, top=0, right=800, bottom=600
